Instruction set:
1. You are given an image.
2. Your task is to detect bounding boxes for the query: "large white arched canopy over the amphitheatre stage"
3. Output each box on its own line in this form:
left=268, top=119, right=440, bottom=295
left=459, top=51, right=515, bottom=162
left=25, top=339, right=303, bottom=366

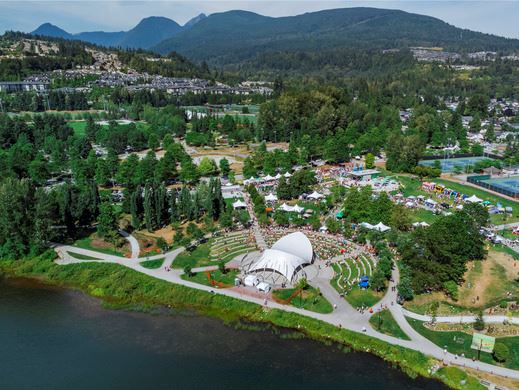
left=248, top=232, right=314, bottom=281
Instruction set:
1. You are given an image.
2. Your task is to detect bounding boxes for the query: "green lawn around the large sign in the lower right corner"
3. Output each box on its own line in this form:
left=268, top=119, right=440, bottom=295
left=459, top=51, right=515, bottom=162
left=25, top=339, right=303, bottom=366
left=407, top=318, right=519, bottom=369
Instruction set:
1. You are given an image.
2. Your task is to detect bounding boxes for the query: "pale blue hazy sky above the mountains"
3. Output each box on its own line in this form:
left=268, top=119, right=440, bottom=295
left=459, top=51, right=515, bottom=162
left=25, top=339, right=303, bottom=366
left=0, top=0, right=519, bottom=38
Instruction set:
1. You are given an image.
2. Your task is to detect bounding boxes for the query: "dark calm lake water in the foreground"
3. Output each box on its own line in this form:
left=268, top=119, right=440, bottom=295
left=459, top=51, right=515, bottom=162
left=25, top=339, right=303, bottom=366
left=0, top=279, right=445, bottom=390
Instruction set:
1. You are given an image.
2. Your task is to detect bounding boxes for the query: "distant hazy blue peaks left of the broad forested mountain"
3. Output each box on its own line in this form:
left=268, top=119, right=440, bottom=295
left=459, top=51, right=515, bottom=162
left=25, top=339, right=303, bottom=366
left=31, top=16, right=182, bottom=49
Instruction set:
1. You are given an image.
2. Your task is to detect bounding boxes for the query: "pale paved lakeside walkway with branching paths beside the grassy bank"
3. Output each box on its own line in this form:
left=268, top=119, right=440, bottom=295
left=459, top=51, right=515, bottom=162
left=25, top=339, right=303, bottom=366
left=55, top=245, right=519, bottom=380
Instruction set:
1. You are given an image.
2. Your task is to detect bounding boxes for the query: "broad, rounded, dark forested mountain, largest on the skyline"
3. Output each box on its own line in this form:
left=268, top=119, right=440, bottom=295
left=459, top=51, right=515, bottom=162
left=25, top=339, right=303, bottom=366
left=152, top=8, right=519, bottom=68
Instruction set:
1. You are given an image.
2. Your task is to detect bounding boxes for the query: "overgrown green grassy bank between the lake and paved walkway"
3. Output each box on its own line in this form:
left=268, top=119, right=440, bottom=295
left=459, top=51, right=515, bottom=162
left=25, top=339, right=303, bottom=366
left=0, top=258, right=484, bottom=389
